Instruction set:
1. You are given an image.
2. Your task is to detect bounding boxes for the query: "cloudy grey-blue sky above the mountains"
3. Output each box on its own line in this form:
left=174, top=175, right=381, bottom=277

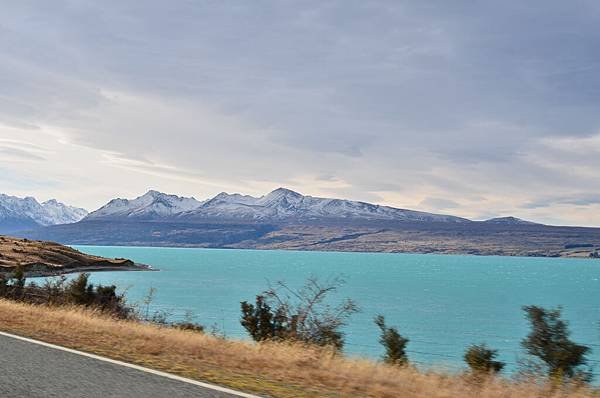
left=0, top=0, right=600, bottom=226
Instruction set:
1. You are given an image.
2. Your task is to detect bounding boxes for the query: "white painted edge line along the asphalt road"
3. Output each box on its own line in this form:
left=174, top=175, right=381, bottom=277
left=0, top=332, right=261, bottom=398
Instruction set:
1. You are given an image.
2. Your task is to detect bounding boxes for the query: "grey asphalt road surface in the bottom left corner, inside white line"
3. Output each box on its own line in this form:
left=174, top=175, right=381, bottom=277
left=0, top=335, right=253, bottom=398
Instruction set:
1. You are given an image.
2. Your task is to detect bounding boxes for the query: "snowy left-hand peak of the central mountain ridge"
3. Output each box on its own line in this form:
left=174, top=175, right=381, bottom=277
left=85, top=191, right=203, bottom=221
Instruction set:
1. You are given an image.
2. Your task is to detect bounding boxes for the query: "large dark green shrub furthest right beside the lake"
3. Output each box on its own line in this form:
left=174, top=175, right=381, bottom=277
left=521, top=306, right=590, bottom=382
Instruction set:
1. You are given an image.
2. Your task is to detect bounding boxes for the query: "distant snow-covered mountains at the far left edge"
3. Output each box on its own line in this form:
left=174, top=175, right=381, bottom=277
left=0, top=194, right=87, bottom=232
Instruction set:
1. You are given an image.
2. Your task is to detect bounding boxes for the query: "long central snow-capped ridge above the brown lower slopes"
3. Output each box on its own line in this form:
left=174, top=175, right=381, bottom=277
left=85, top=188, right=470, bottom=222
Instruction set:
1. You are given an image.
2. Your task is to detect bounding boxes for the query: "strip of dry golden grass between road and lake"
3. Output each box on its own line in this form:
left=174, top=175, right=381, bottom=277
left=0, top=300, right=600, bottom=398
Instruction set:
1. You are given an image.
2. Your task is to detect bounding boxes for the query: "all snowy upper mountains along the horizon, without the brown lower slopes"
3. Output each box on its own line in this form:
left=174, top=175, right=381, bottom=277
left=0, top=188, right=530, bottom=228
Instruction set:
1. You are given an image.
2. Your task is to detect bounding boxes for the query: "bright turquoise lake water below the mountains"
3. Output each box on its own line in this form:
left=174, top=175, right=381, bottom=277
left=64, top=246, right=600, bottom=371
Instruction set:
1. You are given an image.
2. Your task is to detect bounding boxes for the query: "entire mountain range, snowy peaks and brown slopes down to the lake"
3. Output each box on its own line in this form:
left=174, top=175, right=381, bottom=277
left=0, top=188, right=600, bottom=257
